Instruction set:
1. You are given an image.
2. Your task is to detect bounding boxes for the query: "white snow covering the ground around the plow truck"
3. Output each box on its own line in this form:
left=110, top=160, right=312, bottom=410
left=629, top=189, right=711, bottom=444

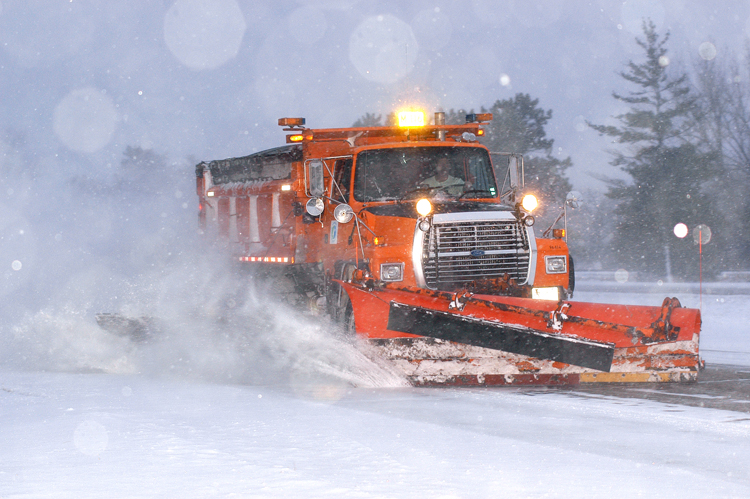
left=0, top=284, right=750, bottom=498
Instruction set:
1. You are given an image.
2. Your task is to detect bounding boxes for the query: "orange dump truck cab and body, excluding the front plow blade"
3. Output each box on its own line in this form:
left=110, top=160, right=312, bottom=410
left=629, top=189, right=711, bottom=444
left=196, top=113, right=573, bottom=309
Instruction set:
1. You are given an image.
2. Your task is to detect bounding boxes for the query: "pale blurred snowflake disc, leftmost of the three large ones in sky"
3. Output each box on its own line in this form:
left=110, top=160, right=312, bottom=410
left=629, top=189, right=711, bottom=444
left=53, top=87, right=117, bottom=153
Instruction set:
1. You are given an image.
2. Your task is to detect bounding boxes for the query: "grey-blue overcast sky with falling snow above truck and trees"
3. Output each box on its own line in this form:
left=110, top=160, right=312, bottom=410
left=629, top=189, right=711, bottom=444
left=0, top=0, right=750, bottom=189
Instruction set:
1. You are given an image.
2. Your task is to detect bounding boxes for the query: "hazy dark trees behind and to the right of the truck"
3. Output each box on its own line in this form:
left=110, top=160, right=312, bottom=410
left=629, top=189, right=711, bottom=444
left=354, top=20, right=750, bottom=280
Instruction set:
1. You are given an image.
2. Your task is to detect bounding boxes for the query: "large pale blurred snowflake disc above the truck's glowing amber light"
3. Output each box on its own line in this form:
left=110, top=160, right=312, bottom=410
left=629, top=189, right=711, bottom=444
left=349, top=15, right=419, bottom=83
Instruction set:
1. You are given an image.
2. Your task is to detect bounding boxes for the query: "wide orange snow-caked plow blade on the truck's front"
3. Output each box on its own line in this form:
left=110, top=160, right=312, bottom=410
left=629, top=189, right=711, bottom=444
left=340, top=282, right=701, bottom=385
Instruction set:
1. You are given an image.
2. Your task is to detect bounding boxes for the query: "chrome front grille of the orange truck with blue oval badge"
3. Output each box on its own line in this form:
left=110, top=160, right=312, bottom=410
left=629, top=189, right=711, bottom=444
left=422, top=220, right=530, bottom=289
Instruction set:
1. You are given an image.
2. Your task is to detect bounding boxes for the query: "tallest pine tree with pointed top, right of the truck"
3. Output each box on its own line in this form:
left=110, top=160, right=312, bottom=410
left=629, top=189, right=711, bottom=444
left=589, top=21, right=714, bottom=278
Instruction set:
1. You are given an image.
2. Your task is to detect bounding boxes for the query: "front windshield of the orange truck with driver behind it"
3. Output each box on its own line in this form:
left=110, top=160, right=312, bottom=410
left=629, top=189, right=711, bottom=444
left=354, top=147, right=497, bottom=202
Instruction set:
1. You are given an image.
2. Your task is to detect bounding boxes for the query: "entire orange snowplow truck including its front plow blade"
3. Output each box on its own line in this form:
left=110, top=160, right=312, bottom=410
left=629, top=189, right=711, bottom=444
left=196, top=112, right=700, bottom=384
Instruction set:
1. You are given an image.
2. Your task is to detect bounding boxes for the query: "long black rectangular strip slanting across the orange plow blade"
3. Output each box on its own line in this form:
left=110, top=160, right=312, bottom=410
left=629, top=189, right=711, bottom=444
left=387, top=302, right=615, bottom=372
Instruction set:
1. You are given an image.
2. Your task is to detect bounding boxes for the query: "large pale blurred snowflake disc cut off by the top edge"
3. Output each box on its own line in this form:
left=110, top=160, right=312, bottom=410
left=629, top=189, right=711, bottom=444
left=164, top=0, right=247, bottom=70
